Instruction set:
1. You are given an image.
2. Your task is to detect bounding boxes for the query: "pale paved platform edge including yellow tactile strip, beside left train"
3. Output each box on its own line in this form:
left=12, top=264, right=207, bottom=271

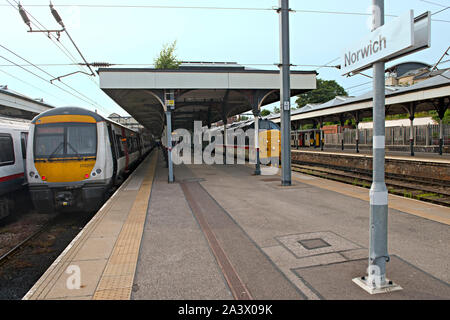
left=23, top=153, right=157, bottom=300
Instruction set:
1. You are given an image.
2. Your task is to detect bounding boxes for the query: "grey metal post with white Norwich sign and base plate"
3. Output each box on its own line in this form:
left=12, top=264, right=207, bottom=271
left=341, top=0, right=430, bottom=294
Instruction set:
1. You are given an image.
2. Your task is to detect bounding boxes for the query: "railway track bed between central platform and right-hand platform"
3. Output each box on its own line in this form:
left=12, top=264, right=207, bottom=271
left=292, top=161, right=450, bottom=207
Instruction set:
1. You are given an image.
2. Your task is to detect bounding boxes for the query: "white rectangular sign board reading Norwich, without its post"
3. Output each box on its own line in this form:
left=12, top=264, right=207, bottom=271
left=341, top=10, right=431, bottom=75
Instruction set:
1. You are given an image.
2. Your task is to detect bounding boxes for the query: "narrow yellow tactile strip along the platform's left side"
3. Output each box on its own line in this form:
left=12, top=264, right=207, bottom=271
left=92, top=150, right=158, bottom=300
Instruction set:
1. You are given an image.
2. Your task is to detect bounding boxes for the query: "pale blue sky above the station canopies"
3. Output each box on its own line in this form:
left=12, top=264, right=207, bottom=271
left=0, top=0, right=450, bottom=116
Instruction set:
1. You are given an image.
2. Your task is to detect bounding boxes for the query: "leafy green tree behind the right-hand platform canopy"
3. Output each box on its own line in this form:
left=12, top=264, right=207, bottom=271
left=295, top=79, right=348, bottom=108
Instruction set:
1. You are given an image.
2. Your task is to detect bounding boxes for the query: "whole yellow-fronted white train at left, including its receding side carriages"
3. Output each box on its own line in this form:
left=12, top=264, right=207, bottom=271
left=27, top=107, right=150, bottom=213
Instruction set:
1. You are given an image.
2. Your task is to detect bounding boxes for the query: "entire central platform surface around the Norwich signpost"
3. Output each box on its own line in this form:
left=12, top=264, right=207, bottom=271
left=24, top=150, right=450, bottom=300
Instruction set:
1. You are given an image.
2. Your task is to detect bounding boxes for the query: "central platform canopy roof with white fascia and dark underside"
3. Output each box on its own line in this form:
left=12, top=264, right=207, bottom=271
left=98, top=63, right=317, bottom=137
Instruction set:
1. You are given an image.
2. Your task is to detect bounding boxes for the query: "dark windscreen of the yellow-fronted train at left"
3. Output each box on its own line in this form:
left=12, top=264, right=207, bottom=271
left=34, top=123, right=97, bottom=160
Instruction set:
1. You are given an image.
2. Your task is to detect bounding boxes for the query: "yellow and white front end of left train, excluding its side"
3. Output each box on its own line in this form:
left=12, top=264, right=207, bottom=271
left=27, top=108, right=113, bottom=212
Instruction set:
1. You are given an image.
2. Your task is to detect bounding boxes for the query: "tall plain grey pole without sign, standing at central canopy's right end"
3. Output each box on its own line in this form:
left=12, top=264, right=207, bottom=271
left=278, top=0, right=291, bottom=186
